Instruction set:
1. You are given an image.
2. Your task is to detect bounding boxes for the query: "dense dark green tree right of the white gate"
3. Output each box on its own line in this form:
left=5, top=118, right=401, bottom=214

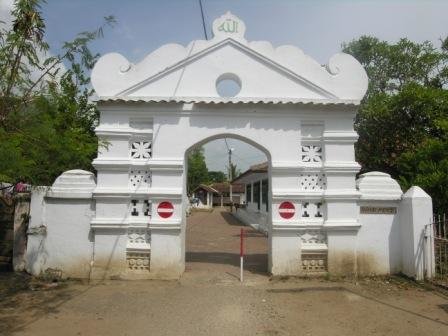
left=344, top=36, right=448, bottom=211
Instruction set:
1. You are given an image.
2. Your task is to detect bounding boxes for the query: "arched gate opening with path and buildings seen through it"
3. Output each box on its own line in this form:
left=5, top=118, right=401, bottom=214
left=183, top=133, right=272, bottom=280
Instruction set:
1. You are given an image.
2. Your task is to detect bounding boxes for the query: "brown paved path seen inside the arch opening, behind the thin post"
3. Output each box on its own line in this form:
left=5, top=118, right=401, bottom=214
left=182, top=208, right=268, bottom=282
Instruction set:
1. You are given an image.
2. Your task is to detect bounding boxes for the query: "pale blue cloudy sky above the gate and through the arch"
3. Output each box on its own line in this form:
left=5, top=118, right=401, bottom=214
left=0, top=0, right=448, bottom=175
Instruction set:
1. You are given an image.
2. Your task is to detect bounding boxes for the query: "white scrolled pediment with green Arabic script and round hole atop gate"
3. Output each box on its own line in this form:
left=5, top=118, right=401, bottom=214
left=92, top=13, right=368, bottom=104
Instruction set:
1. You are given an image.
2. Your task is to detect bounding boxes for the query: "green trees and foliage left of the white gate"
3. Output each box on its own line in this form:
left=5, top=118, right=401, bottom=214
left=0, top=0, right=114, bottom=184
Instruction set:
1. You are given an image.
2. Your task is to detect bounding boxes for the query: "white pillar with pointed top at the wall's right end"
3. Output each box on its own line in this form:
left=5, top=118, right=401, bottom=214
left=399, top=186, right=434, bottom=280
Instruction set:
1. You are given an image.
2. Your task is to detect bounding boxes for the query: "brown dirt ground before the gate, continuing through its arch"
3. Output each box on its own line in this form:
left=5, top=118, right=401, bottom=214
left=0, top=212, right=448, bottom=336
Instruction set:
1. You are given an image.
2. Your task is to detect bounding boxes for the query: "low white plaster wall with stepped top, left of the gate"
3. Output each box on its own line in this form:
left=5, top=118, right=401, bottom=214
left=26, top=170, right=96, bottom=278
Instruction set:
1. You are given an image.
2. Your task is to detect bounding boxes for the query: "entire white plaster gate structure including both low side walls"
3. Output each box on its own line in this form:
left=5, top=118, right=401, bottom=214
left=27, top=13, right=431, bottom=279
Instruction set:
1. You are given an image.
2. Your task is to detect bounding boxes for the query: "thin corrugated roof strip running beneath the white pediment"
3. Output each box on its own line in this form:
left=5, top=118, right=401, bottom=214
left=96, top=96, right=360, bottom=105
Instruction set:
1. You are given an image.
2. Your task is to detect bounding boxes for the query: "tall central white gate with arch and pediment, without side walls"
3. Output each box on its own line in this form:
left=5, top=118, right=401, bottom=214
left=87, top=13, right=367, bottom=278
